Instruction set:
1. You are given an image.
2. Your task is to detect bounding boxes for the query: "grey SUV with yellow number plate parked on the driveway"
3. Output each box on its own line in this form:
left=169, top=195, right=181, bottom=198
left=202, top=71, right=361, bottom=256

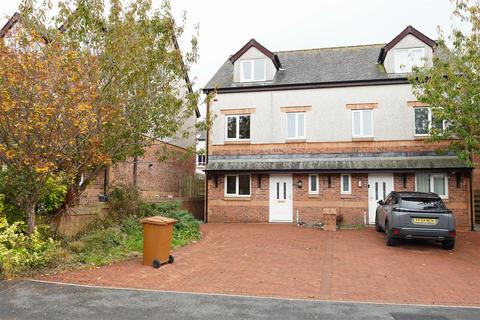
left=375, top=191, right=456, bottom=250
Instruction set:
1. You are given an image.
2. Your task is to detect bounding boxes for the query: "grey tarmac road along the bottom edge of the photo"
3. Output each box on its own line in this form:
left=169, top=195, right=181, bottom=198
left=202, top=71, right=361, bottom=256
left=0, top=280, right=480, bottom=320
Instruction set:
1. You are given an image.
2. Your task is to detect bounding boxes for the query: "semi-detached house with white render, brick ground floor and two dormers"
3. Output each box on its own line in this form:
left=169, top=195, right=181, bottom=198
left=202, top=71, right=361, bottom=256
left=203, top=26, right=474, bottom=230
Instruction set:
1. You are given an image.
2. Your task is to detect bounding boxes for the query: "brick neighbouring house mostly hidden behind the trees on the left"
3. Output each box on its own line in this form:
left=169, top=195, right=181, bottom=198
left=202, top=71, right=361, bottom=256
left=0, top=13, right=203, bottom=233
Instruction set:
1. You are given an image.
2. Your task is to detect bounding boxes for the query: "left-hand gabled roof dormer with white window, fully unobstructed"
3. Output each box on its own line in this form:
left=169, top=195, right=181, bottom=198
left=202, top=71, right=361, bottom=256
left=230, top=39, right=281, bottom=82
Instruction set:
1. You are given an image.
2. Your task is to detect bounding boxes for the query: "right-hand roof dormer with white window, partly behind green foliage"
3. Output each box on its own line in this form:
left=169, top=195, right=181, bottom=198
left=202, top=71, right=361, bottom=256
left=378, top=26, right=437, bottom=73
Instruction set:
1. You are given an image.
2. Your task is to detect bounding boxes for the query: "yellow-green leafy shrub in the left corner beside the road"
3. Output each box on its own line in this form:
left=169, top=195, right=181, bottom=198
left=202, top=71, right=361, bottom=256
left=0, top=218, right=64, bottom=278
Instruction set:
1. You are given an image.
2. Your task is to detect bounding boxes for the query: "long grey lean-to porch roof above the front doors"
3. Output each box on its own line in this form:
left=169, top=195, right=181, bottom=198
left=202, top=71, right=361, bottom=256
left=205, top=153, right=469, bottom=172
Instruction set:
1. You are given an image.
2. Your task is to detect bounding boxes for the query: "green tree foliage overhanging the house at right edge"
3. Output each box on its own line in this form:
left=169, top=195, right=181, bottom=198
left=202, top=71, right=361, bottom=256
left=410, top=0, right=480, bottom=165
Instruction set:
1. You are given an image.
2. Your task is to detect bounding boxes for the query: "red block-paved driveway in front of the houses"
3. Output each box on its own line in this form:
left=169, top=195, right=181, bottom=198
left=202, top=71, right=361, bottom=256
left=40, top=224, right=480, bottom=306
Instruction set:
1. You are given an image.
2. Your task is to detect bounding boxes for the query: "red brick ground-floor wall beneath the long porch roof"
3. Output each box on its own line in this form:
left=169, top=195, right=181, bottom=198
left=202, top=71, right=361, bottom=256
left=208, top=173, right=470, bottom=230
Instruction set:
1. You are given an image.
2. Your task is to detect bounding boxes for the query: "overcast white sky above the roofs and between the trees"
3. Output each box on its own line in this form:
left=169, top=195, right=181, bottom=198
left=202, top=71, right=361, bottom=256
left=0, top=0, right=464, bottom=115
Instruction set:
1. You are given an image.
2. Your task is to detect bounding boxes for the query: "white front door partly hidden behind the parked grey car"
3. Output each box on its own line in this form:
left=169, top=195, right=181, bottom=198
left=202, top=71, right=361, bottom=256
left=368, top=173, right=393, bottom=224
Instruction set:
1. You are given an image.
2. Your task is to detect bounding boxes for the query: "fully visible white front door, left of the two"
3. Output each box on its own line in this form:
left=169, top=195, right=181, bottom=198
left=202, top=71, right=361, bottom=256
left=269, top=174, right=293, bottom=222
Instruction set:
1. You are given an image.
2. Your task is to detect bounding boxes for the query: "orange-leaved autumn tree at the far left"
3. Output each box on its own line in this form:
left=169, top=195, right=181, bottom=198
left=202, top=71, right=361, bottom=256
left=0, top=25, right=109, bottom=233
